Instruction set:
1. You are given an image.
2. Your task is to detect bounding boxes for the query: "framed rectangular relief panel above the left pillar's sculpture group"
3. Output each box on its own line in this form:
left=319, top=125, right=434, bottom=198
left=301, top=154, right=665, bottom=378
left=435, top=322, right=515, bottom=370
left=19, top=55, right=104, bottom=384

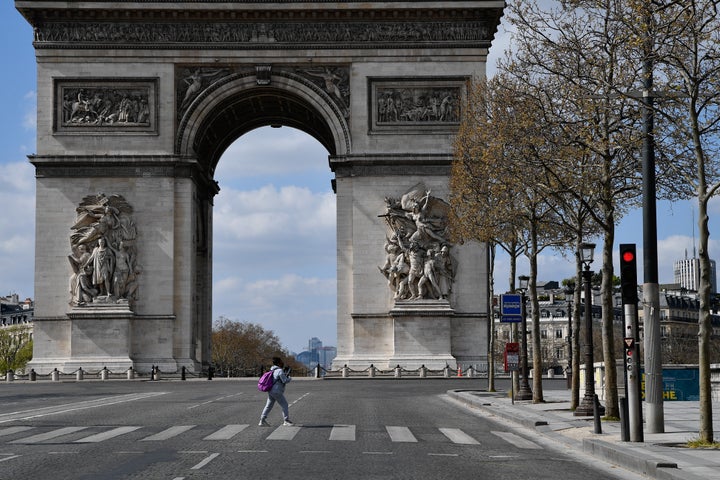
left=53, top=78, right=158, bottom=135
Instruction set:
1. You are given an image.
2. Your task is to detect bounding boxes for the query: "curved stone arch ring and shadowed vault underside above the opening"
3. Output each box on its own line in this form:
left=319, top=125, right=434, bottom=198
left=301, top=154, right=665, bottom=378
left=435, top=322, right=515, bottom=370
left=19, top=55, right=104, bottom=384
left=176, top=72, right=350, bottom=176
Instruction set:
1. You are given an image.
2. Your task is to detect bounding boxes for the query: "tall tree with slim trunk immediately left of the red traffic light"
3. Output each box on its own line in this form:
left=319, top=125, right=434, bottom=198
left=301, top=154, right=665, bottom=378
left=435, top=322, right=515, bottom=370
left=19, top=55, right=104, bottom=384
left=499, top=0, right=640, bottom=417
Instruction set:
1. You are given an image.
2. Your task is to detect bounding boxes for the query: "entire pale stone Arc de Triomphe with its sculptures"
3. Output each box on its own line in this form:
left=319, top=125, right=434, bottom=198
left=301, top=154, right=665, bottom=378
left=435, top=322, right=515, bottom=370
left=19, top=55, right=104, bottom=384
left=15, top=0, right=504, bottom=373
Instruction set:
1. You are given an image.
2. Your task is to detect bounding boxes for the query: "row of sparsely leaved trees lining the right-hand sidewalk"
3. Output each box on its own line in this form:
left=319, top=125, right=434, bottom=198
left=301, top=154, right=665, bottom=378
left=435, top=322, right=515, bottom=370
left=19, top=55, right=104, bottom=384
left=451, top=0, right=720, bottom=442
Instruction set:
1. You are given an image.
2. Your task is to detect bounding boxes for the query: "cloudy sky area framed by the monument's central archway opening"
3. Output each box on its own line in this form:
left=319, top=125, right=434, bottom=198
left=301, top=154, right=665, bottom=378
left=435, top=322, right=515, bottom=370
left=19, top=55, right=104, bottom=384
left=212, top=126, right=337, bottom=352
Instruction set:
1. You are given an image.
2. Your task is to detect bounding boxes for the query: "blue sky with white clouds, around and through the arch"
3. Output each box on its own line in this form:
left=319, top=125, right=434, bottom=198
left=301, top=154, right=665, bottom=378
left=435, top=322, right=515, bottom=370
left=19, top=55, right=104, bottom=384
left=0, top=1, right=720, bottom=352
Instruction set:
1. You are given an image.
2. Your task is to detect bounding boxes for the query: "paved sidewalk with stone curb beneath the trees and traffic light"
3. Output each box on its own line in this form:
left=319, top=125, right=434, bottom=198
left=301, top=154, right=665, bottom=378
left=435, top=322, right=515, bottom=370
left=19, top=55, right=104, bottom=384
left=448, top=390, right=720, bottom=480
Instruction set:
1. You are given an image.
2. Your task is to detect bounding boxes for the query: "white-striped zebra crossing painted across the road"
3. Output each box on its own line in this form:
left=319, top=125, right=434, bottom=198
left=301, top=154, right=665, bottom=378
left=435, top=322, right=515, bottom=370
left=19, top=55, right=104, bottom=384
left=0, top=424, right=542, bottom=449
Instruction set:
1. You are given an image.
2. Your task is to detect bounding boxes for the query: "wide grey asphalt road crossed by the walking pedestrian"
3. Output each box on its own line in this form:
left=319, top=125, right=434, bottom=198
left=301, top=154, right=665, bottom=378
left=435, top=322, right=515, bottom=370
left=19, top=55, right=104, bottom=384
left=0, top=379, right=638, bottom=480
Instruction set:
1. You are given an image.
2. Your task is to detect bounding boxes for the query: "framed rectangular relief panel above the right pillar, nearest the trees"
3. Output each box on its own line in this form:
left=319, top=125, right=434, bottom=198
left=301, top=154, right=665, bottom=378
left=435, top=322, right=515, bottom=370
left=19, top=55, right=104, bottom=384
left=368, top=77, right=469, bottom=134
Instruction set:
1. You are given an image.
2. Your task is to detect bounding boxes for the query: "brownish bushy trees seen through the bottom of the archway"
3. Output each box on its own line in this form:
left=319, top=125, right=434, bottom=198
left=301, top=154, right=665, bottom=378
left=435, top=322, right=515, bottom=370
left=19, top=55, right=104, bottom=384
left=212, top=316, right=302, bottom=377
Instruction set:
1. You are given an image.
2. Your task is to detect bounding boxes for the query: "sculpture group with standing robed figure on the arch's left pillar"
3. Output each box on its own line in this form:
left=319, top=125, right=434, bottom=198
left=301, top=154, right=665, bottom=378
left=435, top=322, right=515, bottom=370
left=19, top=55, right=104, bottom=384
left=68, top=193, right=142, bottom=306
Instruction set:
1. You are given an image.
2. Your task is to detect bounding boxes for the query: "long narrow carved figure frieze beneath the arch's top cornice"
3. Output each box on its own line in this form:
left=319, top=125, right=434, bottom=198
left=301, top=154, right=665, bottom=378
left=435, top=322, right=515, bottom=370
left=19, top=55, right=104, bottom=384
left=35, top=20, right=494, bottom=48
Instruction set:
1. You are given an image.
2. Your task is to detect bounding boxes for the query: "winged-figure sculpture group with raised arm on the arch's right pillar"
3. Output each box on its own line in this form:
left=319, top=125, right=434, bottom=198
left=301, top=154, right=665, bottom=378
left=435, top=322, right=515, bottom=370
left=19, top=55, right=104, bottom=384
left=378, top=183, right=456, bottom=300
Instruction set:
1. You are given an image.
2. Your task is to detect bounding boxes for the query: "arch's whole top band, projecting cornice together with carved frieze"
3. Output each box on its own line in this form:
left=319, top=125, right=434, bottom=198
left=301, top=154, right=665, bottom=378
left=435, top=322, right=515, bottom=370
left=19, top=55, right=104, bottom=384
left=16, top=1, right=503, bottom=49
